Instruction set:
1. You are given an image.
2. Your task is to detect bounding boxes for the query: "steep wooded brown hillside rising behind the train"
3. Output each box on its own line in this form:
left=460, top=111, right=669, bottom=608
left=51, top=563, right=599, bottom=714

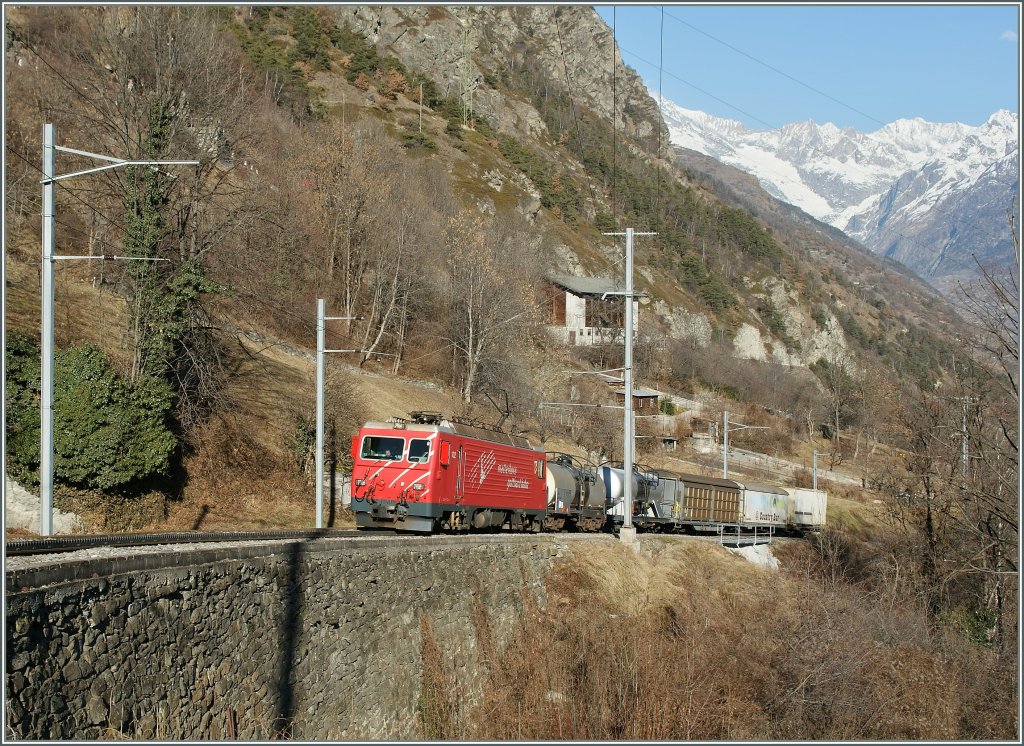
left=5, top=6, right=1019, bottom=724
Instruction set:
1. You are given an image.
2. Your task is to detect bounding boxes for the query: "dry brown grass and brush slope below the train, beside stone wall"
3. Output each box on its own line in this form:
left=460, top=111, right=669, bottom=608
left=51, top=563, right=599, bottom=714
left=415, top=538, right=1016, bottom=741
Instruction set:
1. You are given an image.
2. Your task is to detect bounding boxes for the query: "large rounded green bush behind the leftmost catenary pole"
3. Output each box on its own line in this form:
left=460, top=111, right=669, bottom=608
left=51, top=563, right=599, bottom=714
left=7, top=335, right=177, bottom=491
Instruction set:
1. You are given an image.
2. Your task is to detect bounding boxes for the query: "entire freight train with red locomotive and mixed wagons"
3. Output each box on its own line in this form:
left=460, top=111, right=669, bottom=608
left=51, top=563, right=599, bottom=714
left=351, top=412, right=827, bottom=533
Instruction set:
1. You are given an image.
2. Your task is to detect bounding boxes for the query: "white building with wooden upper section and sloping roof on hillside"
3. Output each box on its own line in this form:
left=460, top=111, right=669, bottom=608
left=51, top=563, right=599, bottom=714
left=545, top=274, right=640, bottom=345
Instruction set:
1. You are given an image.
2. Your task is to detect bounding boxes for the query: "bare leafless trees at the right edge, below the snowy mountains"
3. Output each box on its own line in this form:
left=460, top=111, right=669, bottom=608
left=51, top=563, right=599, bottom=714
left=885, top=203, right=1020, bottom=652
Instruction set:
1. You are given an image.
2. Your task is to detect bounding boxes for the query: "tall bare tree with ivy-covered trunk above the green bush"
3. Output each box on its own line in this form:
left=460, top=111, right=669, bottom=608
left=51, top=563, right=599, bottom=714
left=17, top=6, right=266, bottom=430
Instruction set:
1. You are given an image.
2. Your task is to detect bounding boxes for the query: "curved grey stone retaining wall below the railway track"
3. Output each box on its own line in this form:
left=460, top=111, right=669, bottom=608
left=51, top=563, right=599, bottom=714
left=5, top=535, right=593, bottom=740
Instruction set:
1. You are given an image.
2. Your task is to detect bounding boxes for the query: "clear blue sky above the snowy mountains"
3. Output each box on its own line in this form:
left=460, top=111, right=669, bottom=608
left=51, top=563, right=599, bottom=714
left=595, top=3, right=1021, bottom=132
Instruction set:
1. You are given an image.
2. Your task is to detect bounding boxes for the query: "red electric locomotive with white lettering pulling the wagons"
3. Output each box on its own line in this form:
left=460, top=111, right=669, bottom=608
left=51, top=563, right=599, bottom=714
left=351, top=412, right=547, bottom=533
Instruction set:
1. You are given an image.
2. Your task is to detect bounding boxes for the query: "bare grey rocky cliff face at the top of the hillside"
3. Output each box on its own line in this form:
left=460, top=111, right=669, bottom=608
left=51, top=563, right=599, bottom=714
left=334, top=5, right=671, bottom=156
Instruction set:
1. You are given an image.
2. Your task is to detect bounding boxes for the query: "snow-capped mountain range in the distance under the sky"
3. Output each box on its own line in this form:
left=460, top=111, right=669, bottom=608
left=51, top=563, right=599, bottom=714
left=662, top=96, right=1020, bottom=289
